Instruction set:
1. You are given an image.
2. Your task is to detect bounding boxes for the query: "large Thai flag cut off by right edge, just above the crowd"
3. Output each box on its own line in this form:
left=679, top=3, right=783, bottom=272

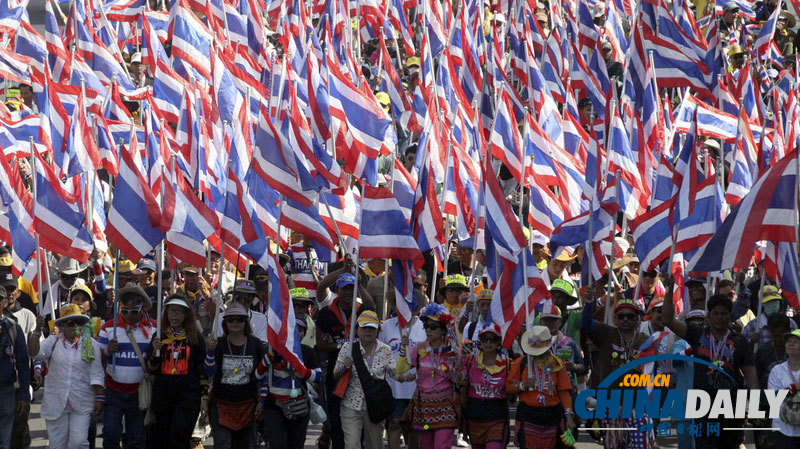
left=688, top=150, right=797, bottom=272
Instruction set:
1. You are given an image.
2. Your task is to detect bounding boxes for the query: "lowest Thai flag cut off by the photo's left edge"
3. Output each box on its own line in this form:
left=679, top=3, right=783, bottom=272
left=0, top=154, right=36, bottom=276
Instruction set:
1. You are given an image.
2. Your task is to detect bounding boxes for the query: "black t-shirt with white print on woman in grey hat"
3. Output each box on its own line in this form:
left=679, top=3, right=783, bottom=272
left=212, top=335, right=264, bottom=402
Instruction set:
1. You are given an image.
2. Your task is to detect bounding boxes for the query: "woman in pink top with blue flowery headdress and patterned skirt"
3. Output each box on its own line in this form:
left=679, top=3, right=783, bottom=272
left=397, top=303, right=461, bottom=449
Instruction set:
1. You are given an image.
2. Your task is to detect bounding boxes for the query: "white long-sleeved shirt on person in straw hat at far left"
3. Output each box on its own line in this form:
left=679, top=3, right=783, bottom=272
left=34, top=335, right=105, bottom=419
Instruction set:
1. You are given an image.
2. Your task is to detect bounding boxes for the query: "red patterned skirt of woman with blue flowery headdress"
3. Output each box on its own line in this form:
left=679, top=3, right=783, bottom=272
left=401, top=390, right=461, bottom=430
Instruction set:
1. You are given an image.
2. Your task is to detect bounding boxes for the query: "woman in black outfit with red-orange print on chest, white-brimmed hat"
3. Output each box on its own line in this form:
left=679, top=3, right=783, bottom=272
left=147, top=294, right=208, bottom=449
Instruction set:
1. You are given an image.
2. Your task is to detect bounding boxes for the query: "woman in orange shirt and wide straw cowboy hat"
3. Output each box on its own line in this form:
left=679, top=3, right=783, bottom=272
left=506, top=326, right=575, bottom=449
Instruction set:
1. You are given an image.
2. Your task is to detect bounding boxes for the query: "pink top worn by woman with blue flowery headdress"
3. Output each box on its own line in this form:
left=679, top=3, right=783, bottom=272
left=406, top=342, right=459, bottom=393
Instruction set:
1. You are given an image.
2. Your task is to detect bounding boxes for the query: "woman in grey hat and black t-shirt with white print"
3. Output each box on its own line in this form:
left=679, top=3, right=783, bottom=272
left=206, top=303, right=266, bottom=449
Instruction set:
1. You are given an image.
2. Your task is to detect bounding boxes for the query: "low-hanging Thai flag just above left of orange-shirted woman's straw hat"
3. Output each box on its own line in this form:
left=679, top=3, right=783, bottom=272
left=487, top=247, right=550, bottom=348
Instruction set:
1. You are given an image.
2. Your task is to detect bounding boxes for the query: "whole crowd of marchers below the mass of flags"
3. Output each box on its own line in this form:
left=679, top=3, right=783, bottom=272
left=0, top=234, right=800, bottom=449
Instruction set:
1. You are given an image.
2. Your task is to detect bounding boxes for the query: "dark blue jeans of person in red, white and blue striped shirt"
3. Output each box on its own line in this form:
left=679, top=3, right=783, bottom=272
left=103, top=388, right=145, bottom=449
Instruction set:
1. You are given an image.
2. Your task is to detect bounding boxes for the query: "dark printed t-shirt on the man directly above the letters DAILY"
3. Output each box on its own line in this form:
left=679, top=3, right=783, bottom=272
left=686, top=324, right=755, bottom=390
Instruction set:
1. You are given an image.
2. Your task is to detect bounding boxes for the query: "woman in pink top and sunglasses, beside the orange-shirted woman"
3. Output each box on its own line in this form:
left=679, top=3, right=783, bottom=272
left=462, top=323, right=510, bottom=449
